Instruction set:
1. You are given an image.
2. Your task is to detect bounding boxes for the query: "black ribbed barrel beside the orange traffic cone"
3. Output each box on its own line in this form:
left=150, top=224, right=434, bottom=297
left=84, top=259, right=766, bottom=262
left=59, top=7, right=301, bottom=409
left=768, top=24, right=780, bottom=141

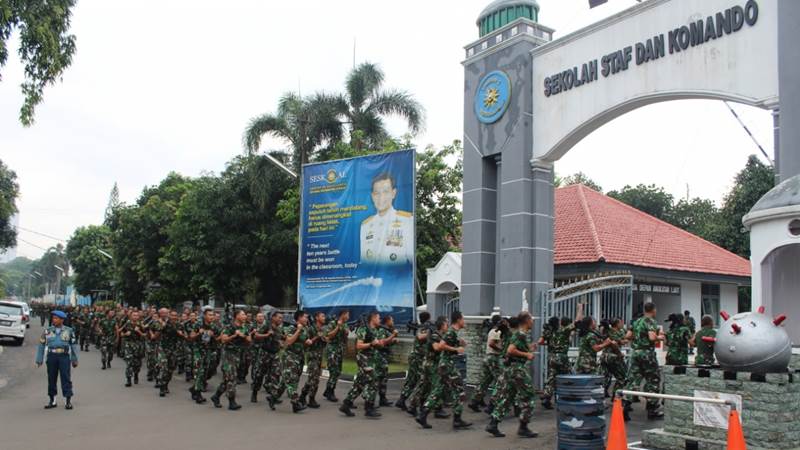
left=556, top=375, right=606, bottom=450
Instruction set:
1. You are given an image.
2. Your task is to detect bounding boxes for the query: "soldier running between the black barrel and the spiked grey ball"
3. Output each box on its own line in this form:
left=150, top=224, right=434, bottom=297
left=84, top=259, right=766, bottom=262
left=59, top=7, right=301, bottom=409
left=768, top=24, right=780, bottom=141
left=623, top=303, right=664, bottom=421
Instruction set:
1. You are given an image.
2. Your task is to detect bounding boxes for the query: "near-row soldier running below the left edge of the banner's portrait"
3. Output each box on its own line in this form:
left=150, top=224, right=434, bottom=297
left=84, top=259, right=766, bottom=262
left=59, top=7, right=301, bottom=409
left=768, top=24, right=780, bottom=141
left=339, top=311, right=385, bottom=418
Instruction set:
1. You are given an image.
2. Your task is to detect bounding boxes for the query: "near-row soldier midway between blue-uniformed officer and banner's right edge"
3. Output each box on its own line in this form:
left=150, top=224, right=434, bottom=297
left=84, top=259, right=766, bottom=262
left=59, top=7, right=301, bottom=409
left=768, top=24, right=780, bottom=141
left=211, top=310, right=251, bottom=411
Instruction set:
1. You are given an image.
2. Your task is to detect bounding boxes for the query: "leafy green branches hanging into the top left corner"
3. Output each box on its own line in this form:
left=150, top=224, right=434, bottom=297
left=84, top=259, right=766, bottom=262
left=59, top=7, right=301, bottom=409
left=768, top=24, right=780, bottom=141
left=0, top=0, right=76, bottom=126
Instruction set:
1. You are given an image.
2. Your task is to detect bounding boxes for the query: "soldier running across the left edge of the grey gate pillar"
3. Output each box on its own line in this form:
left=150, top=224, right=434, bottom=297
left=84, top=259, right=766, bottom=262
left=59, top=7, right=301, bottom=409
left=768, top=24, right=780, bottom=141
left=417, top=311, right=472, bottom=430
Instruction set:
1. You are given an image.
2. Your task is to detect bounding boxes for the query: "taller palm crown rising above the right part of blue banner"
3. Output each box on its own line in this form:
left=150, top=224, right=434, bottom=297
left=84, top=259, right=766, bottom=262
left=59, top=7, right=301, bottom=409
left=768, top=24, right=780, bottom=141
left=311, top=62, right=425, bottom=148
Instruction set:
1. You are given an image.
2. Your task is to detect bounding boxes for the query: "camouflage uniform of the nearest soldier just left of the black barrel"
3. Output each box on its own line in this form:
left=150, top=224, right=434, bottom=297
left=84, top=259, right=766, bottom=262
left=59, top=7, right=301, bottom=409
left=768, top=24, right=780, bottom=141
left=492, top=331, right=536, bottom=423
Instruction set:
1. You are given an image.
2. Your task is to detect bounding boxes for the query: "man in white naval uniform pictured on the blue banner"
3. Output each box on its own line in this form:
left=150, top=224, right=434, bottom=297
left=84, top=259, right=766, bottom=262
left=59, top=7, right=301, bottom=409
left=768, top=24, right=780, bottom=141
left=361, top=173, right=414, bottom=264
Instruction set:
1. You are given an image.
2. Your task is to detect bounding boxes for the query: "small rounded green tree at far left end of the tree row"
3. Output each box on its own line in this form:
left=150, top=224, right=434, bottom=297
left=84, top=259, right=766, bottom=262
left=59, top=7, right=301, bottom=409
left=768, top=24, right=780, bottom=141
left=67, top=225, right=114, bottom=301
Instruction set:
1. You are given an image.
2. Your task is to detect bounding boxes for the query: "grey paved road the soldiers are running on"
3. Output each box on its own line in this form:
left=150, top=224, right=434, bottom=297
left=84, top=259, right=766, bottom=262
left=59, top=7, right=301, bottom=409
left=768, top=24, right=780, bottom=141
left=0, top=324, right=643, bottom=450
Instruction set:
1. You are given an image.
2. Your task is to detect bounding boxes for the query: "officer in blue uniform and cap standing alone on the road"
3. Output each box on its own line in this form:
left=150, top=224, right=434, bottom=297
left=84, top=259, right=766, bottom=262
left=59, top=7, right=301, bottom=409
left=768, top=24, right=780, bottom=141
left=36, top=311, right=78, bottom=409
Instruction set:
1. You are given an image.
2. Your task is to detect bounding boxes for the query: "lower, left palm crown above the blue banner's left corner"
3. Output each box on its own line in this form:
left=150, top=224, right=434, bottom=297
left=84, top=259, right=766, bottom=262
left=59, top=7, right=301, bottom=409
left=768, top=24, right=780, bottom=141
left=244, top=93, right=342, bottom=171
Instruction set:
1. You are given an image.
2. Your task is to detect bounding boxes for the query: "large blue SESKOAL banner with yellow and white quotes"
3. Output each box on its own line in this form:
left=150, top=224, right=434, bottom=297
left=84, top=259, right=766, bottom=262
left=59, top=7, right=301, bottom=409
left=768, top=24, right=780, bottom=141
left=298, top=150, right=416, bottom=323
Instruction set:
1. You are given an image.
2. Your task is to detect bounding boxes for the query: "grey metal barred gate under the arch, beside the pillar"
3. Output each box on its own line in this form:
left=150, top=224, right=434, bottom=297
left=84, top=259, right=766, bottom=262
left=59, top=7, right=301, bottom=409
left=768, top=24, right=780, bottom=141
left=537, top=272, right=633, bottom=388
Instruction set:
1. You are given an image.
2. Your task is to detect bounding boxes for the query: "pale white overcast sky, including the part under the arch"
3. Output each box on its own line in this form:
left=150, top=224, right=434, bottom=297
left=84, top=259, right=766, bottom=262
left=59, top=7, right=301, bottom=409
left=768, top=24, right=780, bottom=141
left=0, top=0, right=773, bottom=258
